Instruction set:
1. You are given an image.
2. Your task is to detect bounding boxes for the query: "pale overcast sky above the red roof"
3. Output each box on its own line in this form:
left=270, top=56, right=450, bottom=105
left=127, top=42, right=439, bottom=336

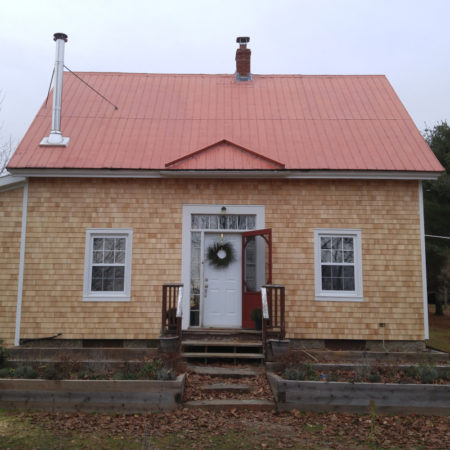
left=0, top=0, right=450, bottom=146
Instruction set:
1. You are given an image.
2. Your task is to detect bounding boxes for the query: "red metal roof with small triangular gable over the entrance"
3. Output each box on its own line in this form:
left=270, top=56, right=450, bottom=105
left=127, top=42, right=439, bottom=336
left=8, top=73, right=443, bottom=172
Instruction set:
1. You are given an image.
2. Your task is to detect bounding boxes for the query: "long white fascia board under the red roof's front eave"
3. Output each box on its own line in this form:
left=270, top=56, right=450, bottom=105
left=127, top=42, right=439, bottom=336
left=10, top=169, right=441, bottom=180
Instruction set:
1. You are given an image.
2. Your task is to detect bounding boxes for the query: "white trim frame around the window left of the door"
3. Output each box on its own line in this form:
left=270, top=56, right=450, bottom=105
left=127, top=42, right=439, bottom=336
left=83, top=228, right=133, bottom=302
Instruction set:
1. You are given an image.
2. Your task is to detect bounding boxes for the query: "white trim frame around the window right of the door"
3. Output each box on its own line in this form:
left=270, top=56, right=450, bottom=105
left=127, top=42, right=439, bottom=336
left=314, top=228, right=364, bottom=302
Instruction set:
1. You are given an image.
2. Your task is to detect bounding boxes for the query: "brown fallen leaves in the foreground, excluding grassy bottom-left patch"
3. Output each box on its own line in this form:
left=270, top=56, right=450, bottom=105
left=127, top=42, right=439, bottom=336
left=19, top=408, right=450, bottom=448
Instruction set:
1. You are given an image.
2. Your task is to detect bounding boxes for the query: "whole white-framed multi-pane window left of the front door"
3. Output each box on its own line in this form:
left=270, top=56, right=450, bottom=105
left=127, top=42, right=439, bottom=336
left=83, top=228, right=133, bottom=301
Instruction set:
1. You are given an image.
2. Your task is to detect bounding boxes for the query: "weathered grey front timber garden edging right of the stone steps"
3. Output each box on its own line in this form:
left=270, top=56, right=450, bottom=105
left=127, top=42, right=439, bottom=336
left=267, top=372, right=450, bottom=416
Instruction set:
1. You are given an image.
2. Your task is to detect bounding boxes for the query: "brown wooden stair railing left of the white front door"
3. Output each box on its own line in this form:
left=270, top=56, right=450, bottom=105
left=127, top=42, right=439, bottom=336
left=161, top=283, right=183, bottom=338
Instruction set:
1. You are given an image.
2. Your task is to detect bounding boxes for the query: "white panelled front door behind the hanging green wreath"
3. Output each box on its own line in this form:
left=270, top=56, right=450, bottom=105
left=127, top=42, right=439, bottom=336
left=203, top=233, right=242, bottom=328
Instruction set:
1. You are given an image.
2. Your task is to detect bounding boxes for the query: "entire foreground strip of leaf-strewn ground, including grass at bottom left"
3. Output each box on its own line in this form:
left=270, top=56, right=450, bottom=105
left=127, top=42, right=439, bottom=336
left=0, top=409, right=450, bottom=449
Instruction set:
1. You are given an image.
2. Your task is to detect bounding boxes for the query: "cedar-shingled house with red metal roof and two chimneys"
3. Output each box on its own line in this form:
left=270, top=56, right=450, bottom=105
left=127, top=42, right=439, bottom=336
left=0, top=34, right=443, bottom=348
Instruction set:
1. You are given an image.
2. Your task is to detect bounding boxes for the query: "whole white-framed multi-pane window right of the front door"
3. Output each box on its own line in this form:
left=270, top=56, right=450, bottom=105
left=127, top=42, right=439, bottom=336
left=314, top=229, right=363, bottom=301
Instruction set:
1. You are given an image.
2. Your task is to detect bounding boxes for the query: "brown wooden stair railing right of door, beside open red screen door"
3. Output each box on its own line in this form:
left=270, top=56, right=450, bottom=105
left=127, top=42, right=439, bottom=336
left=262, top=284, right=286, bottom=342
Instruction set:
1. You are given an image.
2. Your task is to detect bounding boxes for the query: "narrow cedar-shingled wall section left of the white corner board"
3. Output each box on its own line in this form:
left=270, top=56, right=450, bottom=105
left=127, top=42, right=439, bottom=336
left=0, top=187, right=24, bottom=346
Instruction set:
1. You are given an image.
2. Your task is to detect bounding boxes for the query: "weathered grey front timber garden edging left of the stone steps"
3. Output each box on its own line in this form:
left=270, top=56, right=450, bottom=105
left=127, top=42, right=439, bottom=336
left=0, top=374, right=185, bottom=413
